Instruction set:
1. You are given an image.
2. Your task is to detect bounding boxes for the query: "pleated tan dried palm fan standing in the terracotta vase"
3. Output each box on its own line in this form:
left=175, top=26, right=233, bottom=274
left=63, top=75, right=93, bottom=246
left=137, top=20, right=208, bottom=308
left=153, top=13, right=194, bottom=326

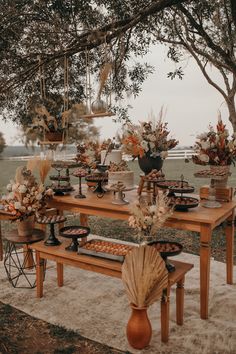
left=122, top=245, right=168, bottom=307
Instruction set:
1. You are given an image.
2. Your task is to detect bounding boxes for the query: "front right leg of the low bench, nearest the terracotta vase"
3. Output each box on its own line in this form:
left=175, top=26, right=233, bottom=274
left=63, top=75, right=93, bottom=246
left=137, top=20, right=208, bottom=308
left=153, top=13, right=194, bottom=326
left=161, top=287, right=170, bottom=343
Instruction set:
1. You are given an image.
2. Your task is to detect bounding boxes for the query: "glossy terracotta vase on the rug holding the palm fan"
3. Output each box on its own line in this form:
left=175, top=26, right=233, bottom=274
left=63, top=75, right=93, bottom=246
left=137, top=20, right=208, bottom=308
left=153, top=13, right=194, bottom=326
left=126, top=305, right=152, bottom=349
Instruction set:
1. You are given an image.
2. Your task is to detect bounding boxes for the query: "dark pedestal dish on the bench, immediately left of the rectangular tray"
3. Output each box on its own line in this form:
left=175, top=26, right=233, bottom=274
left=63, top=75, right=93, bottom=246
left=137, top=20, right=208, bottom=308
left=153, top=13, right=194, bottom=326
left=59, top=226, right=90, bottom=252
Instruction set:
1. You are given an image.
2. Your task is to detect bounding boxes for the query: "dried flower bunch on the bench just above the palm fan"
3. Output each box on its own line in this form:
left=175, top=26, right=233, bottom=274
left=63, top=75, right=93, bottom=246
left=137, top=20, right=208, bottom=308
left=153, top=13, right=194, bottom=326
left=129, top=190, right=173, bottom=241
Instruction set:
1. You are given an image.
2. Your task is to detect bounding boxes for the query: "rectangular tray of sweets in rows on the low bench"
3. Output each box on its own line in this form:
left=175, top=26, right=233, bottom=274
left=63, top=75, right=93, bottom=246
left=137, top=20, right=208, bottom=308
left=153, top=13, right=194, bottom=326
left=78, top=239, right=135, bottom=262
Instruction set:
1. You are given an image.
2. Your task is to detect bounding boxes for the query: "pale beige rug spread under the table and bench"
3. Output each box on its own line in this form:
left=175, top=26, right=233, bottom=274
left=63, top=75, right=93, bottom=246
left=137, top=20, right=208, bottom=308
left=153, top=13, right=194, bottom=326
left=0, top=245, right=236, bottom=354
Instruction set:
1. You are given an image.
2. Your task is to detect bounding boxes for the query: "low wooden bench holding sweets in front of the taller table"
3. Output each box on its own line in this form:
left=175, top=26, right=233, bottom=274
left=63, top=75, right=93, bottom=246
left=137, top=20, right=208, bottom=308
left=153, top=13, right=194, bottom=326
left=28, top=240, right=193, bottom=342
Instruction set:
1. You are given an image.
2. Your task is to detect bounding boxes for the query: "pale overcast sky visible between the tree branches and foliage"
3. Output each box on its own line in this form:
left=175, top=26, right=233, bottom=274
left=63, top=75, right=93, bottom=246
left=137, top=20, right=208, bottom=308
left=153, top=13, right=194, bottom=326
left=0, top=46, right=232, bottom=146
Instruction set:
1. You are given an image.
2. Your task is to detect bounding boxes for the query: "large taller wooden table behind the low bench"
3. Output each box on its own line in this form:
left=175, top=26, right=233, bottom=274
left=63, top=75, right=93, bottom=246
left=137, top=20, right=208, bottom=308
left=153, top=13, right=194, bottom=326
left=49, top=186, right=236, bottom=319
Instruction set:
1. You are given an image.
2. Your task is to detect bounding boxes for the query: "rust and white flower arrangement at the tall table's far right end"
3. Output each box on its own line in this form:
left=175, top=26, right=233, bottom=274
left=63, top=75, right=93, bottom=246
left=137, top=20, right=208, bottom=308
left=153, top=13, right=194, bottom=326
left=192, top=116, right=236, bottom=166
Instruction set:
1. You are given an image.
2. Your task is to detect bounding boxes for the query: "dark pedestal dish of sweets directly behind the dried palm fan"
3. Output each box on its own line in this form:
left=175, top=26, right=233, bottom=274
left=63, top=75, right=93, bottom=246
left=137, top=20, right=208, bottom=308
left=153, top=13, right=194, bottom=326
left=148, top=241, right=183, bottom=273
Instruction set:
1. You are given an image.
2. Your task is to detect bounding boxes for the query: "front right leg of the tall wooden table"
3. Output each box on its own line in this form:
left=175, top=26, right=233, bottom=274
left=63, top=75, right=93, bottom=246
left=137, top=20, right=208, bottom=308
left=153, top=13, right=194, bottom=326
left=200, top=225, right=212, bottom=320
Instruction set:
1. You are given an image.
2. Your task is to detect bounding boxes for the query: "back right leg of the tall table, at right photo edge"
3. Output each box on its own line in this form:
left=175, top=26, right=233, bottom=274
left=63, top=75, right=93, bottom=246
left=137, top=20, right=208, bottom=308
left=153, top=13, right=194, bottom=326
left=225, top=212, right=235, bottom=284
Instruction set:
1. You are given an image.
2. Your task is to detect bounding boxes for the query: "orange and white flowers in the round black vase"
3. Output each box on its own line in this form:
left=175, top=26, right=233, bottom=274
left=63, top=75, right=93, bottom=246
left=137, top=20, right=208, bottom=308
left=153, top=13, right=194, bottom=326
left=122, top=111, right=178, bottom=159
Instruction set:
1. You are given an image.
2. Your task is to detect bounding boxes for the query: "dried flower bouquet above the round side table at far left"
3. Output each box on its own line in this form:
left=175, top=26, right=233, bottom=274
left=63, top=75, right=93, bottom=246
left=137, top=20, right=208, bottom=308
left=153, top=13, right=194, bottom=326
left=2, top=159, right=53, bottom=220
